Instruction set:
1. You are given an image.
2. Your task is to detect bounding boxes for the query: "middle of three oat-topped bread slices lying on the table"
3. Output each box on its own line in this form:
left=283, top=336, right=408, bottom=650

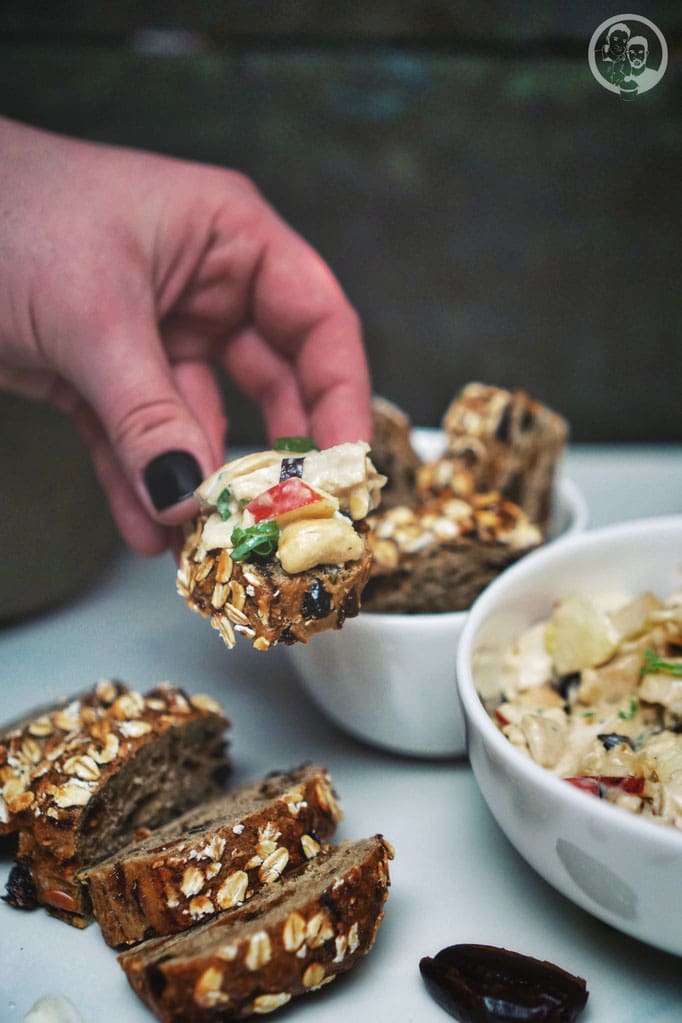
left=84, top=765, right=342, bottom=946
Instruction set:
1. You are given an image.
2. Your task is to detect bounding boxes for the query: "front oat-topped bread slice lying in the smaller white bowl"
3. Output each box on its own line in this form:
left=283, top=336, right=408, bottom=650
left=362, top=491, right=542, bottom=614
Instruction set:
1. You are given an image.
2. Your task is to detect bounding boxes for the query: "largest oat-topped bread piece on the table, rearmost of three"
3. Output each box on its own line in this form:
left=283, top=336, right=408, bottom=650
left=0, top=680, right=229, bottom=927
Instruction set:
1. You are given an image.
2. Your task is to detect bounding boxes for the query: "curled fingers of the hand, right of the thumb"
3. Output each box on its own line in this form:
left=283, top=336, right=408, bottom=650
left=213, top=196, right=371, bottom=446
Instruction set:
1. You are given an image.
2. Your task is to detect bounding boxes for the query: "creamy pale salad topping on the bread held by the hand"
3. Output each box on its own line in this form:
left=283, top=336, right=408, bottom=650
left=195, top=441, right=385, bottom=574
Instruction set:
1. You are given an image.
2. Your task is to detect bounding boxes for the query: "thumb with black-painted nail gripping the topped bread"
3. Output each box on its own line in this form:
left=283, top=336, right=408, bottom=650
left=65, top=321, right=217, bottom=526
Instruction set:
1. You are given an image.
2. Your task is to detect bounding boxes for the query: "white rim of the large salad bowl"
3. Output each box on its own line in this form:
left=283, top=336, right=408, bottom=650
left=456, top=515, right=682, bottom=853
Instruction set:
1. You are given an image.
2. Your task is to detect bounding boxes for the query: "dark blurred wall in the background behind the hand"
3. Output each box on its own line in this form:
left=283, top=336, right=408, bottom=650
left=0, top=0, right=682, bottom=442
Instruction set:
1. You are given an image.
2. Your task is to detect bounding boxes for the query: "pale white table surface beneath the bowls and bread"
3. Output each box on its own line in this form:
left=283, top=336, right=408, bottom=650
left=0, top=446, right=682, bottom=1023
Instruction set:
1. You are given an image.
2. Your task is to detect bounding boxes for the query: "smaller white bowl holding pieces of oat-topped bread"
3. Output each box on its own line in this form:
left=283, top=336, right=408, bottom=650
left=287, top=430, right=587, bottom=757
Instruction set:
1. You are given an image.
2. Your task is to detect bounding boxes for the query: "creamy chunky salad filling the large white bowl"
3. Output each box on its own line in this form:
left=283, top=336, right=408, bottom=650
left=488, top=593, right=682, bottom=829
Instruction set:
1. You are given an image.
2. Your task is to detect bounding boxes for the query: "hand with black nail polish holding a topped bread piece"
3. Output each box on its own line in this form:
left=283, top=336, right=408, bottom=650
left=0, top=119, right=371, bottom=554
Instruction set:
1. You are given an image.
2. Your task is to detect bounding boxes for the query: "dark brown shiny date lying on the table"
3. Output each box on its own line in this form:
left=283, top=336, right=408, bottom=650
left=419, top=944, right=588, bottom=1023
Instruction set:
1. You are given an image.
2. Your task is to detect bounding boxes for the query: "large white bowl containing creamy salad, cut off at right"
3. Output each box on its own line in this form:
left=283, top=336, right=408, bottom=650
left=457, top=516, right=682, bottom=955
